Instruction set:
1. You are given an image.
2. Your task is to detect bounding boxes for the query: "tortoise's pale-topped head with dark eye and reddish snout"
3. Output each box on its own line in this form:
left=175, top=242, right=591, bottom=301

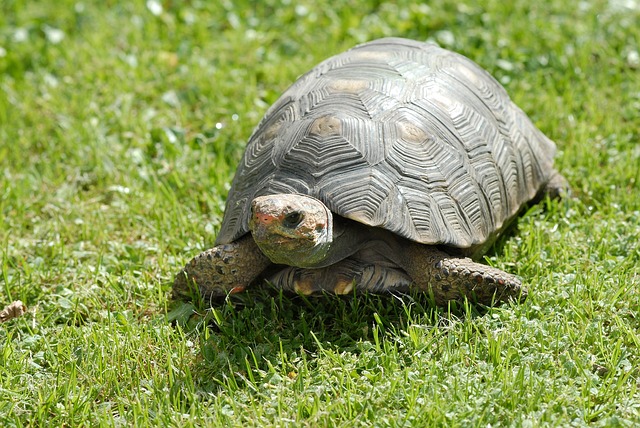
left=249, top=194, right=333, bottom=267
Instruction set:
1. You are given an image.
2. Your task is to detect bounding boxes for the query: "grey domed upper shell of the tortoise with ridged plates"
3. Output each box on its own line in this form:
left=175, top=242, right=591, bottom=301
left=216, top=38, right=555, bottom=248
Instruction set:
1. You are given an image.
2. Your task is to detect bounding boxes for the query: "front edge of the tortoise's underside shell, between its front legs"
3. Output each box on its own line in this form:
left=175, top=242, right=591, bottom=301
left=268, top=258, right=412, bottom=295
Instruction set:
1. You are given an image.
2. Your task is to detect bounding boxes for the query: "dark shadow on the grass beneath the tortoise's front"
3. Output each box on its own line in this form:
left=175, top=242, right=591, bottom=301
left=169, top=287, right=486, bottom=392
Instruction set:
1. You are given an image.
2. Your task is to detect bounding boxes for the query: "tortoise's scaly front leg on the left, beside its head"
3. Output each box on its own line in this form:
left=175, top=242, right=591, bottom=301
left=173, top=234, right=271, bottom=300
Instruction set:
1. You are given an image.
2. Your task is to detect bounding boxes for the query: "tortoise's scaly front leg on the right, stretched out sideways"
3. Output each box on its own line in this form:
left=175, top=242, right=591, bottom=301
left=401, top=243, right=527, bottom=305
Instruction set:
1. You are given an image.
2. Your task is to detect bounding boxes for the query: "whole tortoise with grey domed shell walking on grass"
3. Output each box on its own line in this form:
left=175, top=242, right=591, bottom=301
left=174, top=38, right=567, bottom=305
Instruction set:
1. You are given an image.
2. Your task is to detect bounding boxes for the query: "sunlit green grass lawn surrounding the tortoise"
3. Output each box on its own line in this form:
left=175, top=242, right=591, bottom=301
left=0, top=0, right=640, bottom=427
